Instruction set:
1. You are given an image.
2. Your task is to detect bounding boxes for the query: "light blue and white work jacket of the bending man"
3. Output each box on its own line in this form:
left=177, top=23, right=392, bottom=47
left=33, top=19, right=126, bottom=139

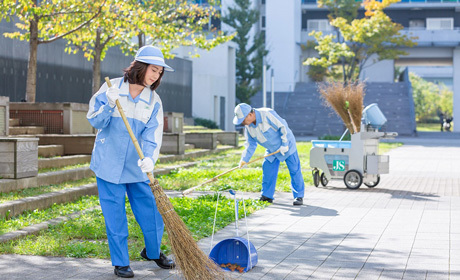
left=241, top=108, right=297, bottom=162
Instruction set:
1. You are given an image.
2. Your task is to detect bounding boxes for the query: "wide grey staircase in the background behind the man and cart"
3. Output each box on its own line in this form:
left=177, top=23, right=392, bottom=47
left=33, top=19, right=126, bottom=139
left=251, top=83, right=415, bottom=136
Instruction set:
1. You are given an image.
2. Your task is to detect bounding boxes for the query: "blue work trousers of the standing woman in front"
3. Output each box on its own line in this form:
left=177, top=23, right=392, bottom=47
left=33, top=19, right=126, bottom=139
left=97, top=178, right=164, bottom=266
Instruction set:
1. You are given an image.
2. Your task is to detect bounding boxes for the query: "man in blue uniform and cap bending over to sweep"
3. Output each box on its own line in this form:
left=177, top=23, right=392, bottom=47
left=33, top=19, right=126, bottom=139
left=233, top=103, right=305, bottom=205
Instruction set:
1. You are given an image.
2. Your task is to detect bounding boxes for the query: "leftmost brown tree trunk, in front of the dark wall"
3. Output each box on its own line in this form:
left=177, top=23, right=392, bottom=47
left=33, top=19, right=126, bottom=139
left=25, top=16, right=39, bottom=102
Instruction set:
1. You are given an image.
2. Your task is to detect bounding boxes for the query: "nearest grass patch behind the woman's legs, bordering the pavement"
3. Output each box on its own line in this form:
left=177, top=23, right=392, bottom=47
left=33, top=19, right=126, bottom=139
left=0, top=195, right=267, bottom=260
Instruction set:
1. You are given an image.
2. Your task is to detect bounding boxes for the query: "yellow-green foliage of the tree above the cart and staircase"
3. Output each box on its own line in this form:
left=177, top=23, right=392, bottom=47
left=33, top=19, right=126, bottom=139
left=304, top=0, right=416, bottom=82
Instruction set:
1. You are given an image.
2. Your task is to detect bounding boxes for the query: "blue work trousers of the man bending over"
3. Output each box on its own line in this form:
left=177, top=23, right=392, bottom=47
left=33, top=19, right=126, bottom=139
left=262, top=151, right=305, bottom=199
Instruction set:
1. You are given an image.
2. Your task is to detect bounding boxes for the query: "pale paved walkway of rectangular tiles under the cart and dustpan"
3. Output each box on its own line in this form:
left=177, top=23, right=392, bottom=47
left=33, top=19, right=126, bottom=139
left=0, top=135, right=460, bottom=280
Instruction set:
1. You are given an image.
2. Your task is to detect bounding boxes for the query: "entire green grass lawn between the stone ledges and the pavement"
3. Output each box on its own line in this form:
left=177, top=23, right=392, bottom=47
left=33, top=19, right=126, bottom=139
left=0, top=142, right=402, bottom=260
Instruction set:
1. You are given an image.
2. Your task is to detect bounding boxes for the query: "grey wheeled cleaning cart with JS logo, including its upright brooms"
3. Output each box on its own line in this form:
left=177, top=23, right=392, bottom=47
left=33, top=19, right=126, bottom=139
left=310, top=82, right=398, bottom=189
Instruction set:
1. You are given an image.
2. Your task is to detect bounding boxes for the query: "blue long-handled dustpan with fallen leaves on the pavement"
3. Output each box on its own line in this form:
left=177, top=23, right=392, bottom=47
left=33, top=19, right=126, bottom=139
left=209, top=190, right=258, bottom=272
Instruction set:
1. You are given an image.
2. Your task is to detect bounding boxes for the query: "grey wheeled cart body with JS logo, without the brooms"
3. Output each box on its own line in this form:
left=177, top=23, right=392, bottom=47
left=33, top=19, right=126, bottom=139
left=310, top=103, right=398, bottom=189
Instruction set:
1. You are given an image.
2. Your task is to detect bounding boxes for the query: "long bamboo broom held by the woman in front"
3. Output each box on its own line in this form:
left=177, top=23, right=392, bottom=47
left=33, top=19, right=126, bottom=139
left=105, top=77, right=227, bottom=280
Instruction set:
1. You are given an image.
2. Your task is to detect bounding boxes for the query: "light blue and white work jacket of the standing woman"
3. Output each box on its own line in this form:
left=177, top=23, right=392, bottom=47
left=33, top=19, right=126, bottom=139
left=87, top=78, right=163, bottom=184
